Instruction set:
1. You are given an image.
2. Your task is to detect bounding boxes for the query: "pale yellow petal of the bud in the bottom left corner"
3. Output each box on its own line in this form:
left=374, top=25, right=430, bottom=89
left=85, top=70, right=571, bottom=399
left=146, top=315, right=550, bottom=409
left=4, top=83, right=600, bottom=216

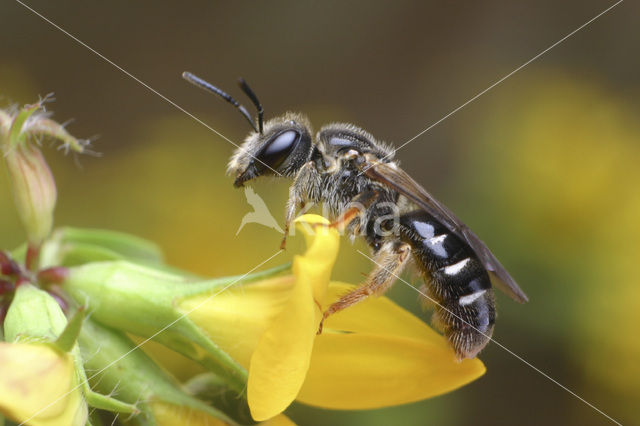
left=0, top=343, right=87, bottom=426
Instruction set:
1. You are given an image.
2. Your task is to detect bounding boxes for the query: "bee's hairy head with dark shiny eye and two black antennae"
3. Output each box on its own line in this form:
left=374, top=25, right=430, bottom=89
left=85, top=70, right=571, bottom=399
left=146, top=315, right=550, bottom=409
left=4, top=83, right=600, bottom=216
left=182, top=72, right=312, bottom=187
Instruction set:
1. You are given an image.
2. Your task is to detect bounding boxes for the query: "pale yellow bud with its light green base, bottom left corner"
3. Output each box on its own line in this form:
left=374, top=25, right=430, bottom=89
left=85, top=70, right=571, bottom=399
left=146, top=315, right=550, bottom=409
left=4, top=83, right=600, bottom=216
left=0, top=283, right=88, bottom=426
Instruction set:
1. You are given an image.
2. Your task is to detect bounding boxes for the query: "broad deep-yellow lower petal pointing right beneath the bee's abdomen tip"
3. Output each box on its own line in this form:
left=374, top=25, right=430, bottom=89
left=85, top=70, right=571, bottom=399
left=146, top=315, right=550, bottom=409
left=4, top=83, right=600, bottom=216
left=297, top=333, right=485, bottom=410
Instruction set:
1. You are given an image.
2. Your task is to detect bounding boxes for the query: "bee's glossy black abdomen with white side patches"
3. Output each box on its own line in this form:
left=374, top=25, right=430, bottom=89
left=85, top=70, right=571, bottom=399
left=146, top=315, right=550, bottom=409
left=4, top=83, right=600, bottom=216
left=400, top=210, right=496, bottom=359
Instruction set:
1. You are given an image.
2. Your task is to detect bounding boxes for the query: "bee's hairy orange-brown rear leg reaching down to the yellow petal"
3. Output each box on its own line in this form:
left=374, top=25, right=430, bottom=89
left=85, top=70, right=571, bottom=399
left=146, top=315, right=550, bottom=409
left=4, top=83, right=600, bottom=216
left=318, top=241, right=411, bottom=334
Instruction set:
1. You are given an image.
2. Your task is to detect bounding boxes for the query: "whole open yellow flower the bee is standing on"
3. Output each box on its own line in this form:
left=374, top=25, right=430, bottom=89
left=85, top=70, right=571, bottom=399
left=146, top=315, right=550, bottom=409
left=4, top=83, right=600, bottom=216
left=178, top=215, right=485, bottom=421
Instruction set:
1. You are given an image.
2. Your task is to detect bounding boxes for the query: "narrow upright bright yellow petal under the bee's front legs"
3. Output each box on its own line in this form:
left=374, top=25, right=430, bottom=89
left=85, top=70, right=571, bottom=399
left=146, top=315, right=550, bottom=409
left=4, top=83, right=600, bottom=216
left=247, top=215, right=339, bottom=421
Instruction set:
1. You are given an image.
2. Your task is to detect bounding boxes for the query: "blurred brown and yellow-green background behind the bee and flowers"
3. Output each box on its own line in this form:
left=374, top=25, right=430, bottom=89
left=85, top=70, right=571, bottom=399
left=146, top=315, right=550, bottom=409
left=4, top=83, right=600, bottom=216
left=0, top=0, right=640, bottom=425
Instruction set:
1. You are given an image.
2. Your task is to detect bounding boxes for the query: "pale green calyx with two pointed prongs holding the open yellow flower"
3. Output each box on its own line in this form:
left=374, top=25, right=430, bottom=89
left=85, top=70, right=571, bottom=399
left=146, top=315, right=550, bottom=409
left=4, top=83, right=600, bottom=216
left=63, top=261, right=283, bottom=393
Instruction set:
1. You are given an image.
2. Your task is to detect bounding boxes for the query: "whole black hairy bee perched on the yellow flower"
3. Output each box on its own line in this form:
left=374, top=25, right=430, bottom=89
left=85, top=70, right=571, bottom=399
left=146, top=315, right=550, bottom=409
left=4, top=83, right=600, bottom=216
left=183, top=72, right=528, bottom=360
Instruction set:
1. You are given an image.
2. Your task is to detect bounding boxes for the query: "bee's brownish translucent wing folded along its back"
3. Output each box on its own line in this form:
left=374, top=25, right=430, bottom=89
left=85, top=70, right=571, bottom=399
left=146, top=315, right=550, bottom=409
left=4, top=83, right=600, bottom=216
left=361, top=162, right=529, bottom=303
